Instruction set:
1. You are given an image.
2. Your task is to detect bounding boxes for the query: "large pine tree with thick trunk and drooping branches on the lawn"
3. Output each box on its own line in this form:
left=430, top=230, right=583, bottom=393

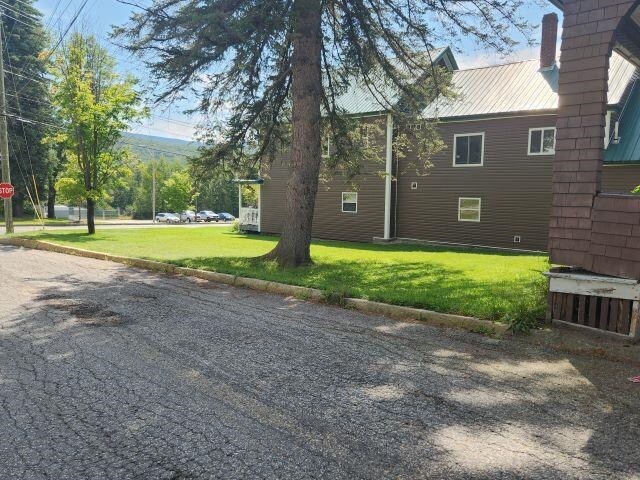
left=116, top=0, right=529, bottom=266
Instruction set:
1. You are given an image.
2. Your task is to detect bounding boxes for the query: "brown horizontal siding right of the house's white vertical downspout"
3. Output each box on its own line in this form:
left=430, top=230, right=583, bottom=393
left=397, top=115, right=555, bottom=250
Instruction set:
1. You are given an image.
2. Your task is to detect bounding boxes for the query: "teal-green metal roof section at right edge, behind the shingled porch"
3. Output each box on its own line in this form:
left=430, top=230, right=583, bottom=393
left=604, top=81, right=640, bottom=164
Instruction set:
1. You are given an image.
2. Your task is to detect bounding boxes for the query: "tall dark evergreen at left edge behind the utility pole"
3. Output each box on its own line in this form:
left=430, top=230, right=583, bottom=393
left=0, top=0, right=51, bottom=216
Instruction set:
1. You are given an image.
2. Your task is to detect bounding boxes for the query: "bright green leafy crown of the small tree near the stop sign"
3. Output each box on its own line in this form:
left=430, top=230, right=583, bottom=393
left=48, top=34, right=146, bottom=232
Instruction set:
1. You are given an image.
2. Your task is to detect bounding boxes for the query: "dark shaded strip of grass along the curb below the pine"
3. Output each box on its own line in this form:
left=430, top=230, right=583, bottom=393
left=171, top=257, right=546, bottom=321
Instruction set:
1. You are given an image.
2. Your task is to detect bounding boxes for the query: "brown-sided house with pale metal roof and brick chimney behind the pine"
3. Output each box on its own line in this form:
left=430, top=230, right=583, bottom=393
left=241, top=10, right=640, bottom=251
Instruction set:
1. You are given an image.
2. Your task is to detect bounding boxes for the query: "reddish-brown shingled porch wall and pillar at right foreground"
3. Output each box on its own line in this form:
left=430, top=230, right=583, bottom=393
left=549, top=0, right=640, bottom=279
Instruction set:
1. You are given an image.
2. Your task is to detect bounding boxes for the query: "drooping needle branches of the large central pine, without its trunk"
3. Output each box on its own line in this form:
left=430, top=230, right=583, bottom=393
left=114, top=0, right=531, bottom=177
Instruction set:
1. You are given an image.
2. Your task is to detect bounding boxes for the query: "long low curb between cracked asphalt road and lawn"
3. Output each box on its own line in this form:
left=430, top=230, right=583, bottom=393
left=0, top=237, right=509, bottom=335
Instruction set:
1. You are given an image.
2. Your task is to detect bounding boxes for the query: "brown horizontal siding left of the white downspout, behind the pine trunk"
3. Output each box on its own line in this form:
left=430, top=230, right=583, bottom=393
left=261, top=117, right=385, bottom=242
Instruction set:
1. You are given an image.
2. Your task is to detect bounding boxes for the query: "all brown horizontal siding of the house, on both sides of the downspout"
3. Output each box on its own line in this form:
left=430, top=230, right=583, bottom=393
left=261, top=115, right=640, bottom=250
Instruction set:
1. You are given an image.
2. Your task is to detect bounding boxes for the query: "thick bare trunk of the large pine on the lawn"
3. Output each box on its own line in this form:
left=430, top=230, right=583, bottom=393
left=266, top=0, right=322, bottom=267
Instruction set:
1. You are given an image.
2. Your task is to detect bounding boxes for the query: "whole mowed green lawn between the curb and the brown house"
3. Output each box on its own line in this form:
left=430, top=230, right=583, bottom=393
left=20, top=227, right=549, bottom=321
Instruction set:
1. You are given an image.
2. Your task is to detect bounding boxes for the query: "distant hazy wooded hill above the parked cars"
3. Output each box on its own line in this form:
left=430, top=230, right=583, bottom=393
left=122, top=133, right=199, bottom=164
